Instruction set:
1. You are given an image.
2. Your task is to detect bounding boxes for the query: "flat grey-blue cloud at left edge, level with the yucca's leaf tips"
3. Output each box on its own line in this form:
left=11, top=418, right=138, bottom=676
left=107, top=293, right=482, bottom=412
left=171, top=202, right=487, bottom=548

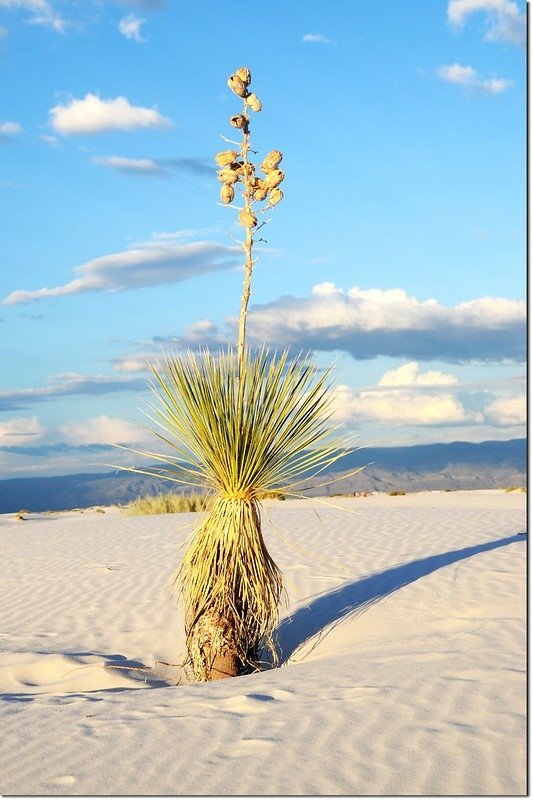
left=0, top=372, right=146, bottom=411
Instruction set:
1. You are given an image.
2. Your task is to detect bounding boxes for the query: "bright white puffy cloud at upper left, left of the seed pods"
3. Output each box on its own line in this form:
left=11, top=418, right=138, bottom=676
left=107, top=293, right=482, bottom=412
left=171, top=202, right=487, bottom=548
left=49, top=93, right=172, bottom=134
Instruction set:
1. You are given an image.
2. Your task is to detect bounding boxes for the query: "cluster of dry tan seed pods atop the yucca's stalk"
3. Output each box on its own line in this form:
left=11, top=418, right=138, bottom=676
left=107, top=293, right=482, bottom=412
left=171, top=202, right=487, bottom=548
left=215, top=67, right=285, bottom=227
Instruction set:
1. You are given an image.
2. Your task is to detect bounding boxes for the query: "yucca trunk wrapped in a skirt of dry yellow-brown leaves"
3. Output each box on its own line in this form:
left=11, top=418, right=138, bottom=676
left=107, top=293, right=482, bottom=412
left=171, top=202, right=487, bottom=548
left=181, top=497, right=282, bottom=681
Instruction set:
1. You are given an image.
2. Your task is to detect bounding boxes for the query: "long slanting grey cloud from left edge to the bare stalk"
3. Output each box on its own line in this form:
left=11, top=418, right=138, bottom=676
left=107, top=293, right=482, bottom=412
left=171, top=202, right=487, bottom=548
left=1, top=238, right=241, bottom=306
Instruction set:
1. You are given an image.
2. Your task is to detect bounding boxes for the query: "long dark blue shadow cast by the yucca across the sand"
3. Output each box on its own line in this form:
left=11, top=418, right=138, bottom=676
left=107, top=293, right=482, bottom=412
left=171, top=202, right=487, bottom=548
left=277, top=533, right=525, bottom=664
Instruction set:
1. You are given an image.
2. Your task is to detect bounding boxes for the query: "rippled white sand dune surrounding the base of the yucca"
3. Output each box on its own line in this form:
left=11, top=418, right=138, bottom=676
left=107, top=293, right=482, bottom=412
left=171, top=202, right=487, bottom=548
left=0, top=491, right=526, bottom=796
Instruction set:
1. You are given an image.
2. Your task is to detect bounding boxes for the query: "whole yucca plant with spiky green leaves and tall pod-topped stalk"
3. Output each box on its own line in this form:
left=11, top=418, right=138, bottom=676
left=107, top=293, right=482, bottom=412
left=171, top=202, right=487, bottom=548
left=121, top=67, right=354, bottom=681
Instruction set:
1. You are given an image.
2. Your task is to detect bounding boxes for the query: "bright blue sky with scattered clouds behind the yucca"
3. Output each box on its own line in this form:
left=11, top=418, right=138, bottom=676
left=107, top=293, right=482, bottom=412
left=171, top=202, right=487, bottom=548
left=0, top=0, right=526, bottom=477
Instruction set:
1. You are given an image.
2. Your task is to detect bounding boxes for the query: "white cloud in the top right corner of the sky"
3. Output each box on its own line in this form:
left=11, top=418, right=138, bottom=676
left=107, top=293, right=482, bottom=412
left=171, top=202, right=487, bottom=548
left=448, top=0, right=526, bottom=45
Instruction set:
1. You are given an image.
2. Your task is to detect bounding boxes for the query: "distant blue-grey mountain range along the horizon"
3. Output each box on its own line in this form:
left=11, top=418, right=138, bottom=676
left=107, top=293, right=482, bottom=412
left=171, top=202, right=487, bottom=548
left=0, top=439, right=527, bottom=514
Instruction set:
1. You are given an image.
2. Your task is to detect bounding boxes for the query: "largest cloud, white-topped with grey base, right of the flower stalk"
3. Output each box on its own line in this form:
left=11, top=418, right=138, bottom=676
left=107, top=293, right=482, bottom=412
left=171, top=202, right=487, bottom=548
left=240, top=283, right=525, bottom=362
